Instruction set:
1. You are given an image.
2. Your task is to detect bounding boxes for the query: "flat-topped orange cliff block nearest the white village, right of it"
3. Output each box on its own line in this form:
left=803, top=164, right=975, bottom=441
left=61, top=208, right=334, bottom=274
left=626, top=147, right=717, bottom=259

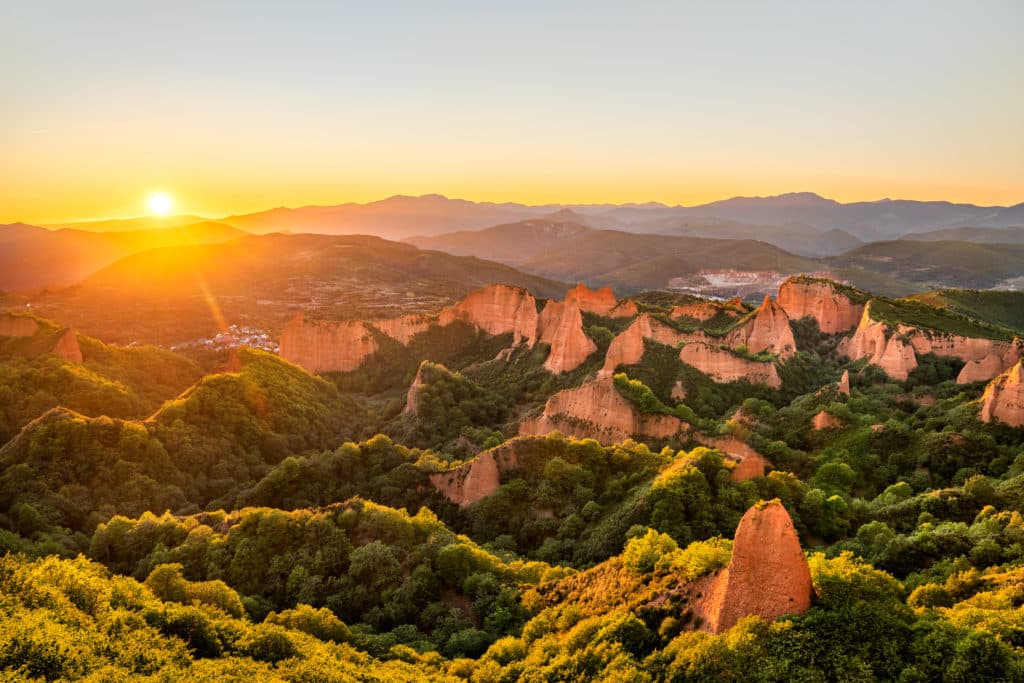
left=279, top=313, right=377, bottom=373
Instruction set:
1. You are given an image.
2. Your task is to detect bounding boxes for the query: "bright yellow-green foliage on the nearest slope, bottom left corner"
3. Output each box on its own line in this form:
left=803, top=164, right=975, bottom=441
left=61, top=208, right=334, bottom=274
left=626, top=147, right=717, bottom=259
left=0, top=555, right=449, bottom=682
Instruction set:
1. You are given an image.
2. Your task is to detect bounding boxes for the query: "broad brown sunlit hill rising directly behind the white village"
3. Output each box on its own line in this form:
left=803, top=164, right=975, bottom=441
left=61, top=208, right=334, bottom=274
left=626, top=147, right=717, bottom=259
left=25, top=234, right=565, bottom=344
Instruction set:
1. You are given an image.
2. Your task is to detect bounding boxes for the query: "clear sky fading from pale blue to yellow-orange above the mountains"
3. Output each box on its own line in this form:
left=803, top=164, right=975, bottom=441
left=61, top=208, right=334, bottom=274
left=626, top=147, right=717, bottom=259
left=0, top=0, right=1024, bottom=223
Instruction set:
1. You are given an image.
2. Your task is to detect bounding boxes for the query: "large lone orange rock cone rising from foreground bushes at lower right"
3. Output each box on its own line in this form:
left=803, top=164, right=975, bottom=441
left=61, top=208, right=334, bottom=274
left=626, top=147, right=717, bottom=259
left=696, top=500, right=813, bottom=633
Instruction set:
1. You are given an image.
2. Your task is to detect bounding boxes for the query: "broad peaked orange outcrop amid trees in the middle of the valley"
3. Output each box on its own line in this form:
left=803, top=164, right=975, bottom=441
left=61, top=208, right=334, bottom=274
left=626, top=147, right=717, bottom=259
left=519, top=377, right=684, bottom=443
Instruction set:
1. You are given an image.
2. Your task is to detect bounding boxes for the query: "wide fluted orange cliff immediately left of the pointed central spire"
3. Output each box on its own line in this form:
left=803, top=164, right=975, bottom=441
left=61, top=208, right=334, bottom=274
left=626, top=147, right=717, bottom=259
left=438, top=285, right=538, bottom=346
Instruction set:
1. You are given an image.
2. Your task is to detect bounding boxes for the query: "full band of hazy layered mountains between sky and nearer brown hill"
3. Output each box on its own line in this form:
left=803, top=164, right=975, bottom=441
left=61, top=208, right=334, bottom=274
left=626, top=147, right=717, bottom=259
left=6, top=193, right=1024, bottom=295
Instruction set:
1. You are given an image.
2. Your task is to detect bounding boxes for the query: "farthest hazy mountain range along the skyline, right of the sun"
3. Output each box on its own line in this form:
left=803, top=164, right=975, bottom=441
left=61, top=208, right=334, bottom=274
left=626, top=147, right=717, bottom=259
left=209, top=193, right=1024, bottom=245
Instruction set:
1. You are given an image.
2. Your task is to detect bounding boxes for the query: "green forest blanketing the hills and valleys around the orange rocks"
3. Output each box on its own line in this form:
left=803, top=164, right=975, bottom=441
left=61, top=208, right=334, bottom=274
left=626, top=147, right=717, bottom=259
left=0, top=284, right=1024, bottom=683
